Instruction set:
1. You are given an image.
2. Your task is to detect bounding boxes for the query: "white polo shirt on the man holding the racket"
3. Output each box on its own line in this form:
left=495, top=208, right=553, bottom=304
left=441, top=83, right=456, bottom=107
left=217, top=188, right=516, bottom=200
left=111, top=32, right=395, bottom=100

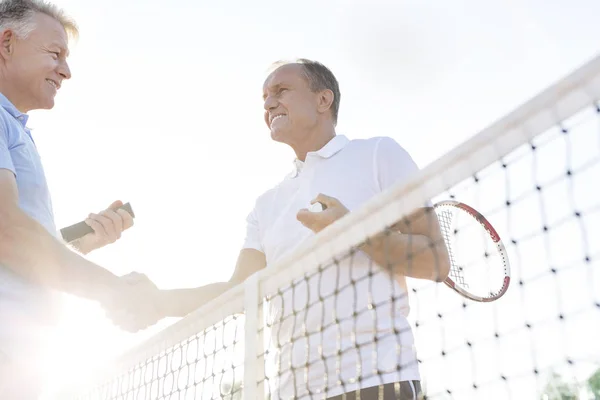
left=244, top=135, right=420, bottom=400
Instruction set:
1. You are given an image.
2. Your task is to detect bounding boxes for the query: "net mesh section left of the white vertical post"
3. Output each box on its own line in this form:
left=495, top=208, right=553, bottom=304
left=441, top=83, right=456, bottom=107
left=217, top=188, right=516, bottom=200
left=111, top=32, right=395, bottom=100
left=82, top=316, right=244, bottom=400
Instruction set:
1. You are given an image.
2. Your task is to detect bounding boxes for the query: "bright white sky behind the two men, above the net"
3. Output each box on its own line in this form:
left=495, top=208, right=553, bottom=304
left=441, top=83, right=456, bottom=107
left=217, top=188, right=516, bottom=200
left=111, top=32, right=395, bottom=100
left=29, top=0, right=600, bottom=398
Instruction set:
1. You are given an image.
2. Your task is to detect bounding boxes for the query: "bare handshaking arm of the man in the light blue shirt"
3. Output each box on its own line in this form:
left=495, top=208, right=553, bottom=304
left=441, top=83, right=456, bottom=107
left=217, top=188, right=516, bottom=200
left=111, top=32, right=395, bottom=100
left=0, top=169, right=119, bottom=300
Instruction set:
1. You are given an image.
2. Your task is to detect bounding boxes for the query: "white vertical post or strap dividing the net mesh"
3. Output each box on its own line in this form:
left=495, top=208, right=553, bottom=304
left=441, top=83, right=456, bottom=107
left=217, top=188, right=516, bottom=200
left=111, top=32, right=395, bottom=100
left=243, top=274, right=264, bottom=399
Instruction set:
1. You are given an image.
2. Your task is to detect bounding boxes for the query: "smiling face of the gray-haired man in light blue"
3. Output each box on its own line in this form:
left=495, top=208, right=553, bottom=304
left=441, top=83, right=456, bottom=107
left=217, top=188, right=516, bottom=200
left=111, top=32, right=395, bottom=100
left=0, top=13, right=71, bottom=113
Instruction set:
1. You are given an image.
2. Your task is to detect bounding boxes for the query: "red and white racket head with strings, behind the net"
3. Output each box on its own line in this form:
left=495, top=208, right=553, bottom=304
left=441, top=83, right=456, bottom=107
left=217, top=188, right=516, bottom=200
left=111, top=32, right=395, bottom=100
left=434, top=200, right=510, bottom=303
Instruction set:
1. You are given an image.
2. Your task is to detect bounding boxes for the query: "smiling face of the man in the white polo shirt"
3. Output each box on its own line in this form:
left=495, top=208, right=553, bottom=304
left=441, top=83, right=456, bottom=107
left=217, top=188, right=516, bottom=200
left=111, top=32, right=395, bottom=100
left=263, top=64, right=321, bottom=144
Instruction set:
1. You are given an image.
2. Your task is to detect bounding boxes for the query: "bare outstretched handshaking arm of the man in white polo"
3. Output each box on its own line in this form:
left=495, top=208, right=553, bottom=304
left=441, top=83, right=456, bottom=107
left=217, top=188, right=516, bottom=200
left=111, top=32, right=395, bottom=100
left=158, top=249, right=267, bottom=317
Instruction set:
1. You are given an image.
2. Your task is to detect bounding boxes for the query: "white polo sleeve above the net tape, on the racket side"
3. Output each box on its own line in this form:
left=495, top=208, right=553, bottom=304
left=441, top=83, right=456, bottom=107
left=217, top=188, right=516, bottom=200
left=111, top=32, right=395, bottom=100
left=374, top=137, right=419, bottom=192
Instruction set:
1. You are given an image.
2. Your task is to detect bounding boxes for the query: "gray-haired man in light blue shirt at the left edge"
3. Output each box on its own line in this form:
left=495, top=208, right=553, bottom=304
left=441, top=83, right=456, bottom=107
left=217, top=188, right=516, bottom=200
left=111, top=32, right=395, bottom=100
left=0, top=0, right=155, bottom=400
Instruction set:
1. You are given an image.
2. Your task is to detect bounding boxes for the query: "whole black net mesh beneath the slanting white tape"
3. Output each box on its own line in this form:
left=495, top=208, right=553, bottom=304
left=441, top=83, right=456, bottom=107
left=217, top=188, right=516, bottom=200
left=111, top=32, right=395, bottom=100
left=62, top=67, right=600, bottom=400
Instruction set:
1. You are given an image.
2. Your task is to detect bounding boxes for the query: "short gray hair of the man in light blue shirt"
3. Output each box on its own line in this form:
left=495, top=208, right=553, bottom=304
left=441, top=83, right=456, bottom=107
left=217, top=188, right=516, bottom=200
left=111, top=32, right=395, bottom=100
left=0, top=0, right=79, bottom=39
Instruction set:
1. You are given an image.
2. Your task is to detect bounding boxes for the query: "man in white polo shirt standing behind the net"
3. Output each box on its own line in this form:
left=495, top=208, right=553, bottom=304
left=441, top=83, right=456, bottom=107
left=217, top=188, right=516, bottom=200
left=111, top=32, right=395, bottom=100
left=120, top=59, right=449, bottom=400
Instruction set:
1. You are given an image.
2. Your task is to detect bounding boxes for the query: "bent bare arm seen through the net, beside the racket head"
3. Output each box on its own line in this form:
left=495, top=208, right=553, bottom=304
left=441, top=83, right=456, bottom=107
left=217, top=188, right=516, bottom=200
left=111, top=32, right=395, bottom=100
left=361, top=208, right=450, bottom=282
